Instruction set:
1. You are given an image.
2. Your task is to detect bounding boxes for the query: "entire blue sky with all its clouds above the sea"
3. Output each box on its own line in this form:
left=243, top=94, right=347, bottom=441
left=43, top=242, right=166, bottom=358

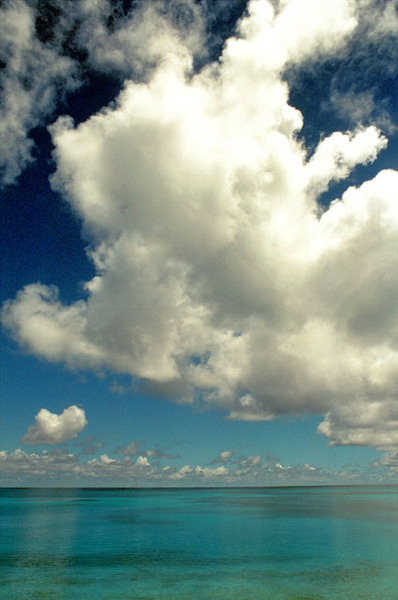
left=0, top=0, right=398, bottom=487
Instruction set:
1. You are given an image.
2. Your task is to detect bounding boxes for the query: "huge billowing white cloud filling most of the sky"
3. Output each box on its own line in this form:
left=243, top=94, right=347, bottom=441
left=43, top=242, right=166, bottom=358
left=2, top=0, right=398, bottom=450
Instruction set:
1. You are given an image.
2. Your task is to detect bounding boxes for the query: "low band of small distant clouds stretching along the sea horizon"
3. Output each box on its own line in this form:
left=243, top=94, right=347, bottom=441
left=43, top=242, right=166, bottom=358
left=0, top=448, right=397, bottom=487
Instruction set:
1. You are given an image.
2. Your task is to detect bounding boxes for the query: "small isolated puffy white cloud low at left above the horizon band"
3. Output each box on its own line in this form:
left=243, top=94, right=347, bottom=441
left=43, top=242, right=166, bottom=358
left=21, top=405, right=87, bottom=446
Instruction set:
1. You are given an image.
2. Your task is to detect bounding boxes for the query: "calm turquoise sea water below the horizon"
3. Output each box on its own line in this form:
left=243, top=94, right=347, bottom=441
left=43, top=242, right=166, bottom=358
left=0, top=486, right=398, bottom=600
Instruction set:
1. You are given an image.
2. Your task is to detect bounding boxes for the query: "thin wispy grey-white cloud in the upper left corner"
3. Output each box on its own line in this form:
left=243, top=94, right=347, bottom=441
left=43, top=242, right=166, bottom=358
left=0, top=0, right=76, bottom=185
